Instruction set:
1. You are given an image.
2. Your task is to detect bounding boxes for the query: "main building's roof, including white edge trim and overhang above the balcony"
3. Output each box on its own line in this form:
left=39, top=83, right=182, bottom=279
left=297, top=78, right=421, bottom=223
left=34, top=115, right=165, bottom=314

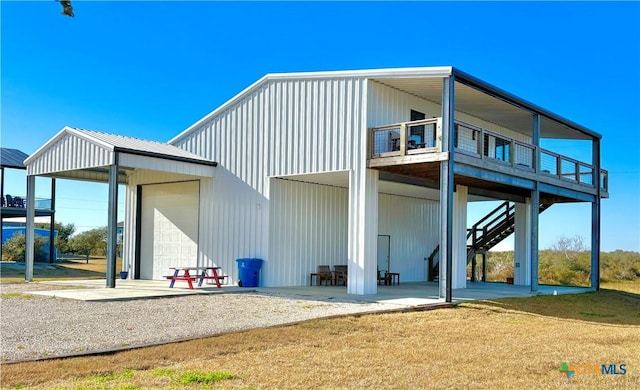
left=169, top=66, right=601, bottom=143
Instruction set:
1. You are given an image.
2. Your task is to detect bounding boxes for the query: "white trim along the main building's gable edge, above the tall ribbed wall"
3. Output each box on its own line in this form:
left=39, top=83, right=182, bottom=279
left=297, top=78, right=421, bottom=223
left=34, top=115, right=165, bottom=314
left=167, top=66, right=453, bottom=144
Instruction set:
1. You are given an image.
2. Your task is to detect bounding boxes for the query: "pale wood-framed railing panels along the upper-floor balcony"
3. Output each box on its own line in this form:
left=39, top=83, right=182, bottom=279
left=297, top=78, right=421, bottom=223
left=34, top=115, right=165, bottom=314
left=369, top=118, right=609, bottom=191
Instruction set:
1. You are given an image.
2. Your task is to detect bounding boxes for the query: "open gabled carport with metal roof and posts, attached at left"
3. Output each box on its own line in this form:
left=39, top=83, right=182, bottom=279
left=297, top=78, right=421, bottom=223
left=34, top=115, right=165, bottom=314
left=24, top=127, right=218, bottom=287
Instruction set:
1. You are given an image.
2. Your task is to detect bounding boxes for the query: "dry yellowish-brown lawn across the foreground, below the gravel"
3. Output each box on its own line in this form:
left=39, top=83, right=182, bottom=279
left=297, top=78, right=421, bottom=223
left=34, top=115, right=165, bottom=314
left=0, top=285, right=640, bottom=389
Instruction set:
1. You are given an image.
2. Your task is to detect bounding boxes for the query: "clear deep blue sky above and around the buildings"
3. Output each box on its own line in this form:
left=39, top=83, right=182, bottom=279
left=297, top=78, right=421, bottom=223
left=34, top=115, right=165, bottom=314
left=0, top=1, right=640, bottom=251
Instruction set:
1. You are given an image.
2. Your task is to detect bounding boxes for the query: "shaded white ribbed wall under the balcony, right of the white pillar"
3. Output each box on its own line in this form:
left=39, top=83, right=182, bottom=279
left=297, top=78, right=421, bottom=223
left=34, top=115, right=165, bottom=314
left=378, top=194, right=440, bottom=282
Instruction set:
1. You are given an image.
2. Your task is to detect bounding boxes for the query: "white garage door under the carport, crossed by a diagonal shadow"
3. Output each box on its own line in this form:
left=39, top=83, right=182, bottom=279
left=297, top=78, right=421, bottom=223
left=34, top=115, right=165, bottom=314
left=140, top=181, right=200, bottom=279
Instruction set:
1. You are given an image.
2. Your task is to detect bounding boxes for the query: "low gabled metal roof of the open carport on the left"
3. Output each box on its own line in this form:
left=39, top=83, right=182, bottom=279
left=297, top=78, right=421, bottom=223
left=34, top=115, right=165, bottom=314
left=24, top=126, right=217, bottom=166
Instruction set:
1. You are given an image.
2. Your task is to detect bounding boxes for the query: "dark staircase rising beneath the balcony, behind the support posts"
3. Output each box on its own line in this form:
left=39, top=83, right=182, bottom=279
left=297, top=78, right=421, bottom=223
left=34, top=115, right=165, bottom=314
left=428, top=201, right=552, bottom=281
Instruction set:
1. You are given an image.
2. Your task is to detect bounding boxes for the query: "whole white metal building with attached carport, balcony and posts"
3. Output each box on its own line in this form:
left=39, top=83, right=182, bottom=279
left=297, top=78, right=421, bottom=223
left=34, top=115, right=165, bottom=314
left=26, top=67, right=608, bottom=300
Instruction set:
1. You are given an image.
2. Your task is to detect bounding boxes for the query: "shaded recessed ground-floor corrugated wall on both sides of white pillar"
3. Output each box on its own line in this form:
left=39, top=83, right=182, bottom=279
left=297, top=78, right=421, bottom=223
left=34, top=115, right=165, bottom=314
left=262, top=179, right=439, bottom=286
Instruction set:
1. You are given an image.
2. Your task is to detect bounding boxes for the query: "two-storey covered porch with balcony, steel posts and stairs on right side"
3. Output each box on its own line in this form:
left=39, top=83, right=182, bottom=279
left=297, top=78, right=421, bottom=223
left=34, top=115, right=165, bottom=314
left=365, top=68, right=608, bottom=301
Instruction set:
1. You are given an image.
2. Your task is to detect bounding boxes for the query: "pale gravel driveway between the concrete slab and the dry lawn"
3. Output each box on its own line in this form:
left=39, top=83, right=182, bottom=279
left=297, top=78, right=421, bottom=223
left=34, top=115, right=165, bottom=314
left=0, top=283, right=398, bottom=362
